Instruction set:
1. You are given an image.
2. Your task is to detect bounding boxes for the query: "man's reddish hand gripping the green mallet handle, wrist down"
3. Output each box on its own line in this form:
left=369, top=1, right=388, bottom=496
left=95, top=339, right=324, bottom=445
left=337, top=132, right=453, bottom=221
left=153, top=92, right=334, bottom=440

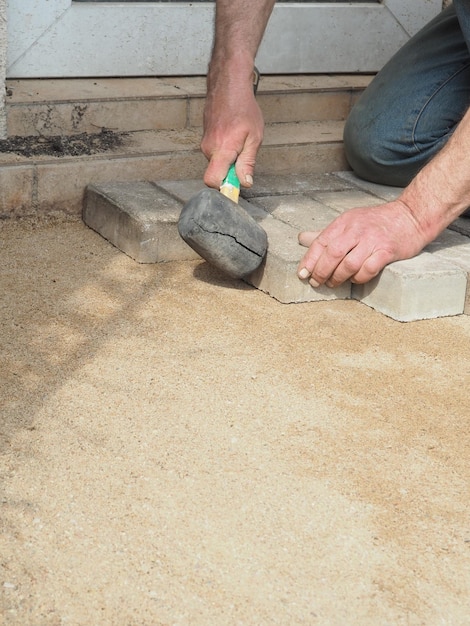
left=201, top=73, right=264, bottom=189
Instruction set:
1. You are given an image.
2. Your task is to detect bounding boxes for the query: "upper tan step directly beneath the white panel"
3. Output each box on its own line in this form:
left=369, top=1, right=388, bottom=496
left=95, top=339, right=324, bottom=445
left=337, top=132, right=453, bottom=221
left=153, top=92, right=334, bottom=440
left=6, top=75, right=371, bottom=136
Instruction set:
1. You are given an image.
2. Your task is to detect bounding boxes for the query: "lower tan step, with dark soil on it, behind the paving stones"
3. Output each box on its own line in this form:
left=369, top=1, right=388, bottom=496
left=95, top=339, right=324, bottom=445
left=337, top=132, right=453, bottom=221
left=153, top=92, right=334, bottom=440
left=0, top=121, right=347, bottom=218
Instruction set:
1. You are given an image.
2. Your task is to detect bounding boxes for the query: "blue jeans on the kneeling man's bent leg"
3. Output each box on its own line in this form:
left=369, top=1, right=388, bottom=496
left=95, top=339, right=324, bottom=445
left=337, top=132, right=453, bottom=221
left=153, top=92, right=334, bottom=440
left=344, top=0, right=470, bottom=187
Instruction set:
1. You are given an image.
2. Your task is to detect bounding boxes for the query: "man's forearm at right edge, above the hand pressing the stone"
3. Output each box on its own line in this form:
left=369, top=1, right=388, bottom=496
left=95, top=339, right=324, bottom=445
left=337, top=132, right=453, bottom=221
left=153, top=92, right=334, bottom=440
left=400, top=109, right=470, bottom=242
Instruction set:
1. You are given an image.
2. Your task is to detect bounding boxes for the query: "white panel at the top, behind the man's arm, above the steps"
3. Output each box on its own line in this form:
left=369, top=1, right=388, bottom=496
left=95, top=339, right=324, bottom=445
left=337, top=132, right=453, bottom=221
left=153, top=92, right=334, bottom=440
left=7, top=0, right=441, bottom=78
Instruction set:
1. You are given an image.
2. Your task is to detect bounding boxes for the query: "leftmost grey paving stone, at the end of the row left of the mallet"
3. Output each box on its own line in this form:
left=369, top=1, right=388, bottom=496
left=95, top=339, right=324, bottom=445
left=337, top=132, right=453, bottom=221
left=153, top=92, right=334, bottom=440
left=82, top=182, right=199, bottom=263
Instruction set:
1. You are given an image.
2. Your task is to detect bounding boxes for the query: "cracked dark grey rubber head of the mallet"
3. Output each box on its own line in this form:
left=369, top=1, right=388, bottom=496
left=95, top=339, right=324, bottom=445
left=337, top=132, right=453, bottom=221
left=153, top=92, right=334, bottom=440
left=178, top=188, right=268, bottom=278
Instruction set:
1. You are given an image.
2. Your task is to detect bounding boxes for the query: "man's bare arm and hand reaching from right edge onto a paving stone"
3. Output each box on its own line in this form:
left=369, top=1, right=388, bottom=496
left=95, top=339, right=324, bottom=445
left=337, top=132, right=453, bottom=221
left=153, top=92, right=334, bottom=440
left=298, top=110, right=470, bottom=287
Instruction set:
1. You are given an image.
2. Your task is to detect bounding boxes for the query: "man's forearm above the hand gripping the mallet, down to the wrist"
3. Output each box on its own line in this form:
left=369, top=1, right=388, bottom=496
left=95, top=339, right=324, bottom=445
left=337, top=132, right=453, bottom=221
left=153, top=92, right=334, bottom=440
left=209, top=0, right=275, bottom=79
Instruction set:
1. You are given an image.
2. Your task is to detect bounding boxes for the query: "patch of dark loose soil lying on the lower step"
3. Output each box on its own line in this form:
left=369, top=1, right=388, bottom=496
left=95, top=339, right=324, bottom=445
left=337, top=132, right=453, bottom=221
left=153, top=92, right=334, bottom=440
left=0, top=128, right=127, bottom=157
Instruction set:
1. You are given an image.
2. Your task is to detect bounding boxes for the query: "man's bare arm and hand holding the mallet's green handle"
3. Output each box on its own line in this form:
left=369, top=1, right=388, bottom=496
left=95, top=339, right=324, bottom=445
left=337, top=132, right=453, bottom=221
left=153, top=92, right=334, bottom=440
left=201, top=0, right=275, bottom=187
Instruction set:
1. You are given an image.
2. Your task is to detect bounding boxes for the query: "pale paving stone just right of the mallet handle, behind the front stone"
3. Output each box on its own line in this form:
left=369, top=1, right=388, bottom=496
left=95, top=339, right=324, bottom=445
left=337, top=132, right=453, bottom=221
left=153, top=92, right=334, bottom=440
left=255, top=195, right=338, bottom=231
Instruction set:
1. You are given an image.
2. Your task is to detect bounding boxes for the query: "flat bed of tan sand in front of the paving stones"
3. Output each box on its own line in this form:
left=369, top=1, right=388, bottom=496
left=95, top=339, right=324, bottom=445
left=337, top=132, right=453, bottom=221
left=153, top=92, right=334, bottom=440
left=0, top=221, right=470, bottom=626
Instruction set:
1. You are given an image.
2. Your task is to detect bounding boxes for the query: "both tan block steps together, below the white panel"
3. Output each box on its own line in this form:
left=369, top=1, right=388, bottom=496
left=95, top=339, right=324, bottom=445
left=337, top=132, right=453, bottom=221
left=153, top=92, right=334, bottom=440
left=0, top=75, right=371, bottom=217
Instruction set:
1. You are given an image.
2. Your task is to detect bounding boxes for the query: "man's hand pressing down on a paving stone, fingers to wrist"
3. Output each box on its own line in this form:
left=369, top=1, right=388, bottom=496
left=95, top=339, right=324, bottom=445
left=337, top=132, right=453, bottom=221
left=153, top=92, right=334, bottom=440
left=298, top=200, right=429, bottom=287
